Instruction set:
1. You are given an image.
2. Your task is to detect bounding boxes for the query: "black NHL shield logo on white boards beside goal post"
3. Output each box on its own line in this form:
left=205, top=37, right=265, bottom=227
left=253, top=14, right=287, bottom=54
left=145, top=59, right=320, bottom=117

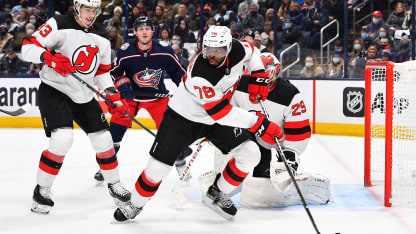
left=343, top=87, right=365, bottom=117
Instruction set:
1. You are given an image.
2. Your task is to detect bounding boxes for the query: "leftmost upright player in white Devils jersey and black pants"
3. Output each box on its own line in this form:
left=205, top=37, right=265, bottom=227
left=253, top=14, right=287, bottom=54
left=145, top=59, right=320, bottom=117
left=22, top=0, right=131, bottom=214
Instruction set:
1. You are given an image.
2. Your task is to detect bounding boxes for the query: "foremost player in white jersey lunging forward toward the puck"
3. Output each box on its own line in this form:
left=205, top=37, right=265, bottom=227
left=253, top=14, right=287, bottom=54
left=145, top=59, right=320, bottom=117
left=114, top=26, right=283, bottom=221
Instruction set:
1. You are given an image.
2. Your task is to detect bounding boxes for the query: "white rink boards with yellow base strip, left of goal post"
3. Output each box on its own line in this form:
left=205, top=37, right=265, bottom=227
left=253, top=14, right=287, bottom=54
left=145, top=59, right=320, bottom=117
left=0, top=78, right=364, bottom=136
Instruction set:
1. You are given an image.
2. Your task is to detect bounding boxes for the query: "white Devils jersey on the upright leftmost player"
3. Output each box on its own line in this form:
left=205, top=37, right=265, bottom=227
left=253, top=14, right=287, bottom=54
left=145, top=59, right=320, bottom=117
left=22, top=15, right=114, bottom=103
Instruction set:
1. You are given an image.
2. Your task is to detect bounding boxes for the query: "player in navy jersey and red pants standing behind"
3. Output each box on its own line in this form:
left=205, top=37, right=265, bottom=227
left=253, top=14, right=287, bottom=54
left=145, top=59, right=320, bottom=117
left=94, top=16, right=192, bottom=185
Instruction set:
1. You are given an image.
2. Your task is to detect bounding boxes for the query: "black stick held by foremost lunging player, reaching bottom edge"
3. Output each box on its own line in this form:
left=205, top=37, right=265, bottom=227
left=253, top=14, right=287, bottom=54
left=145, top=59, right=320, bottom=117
left=259, top=100, right=320, bottom=234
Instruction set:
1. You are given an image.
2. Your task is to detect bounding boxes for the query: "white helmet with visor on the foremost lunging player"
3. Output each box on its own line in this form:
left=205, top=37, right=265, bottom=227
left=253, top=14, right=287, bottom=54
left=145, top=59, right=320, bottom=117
left=202, top=26, right=233, bottom=67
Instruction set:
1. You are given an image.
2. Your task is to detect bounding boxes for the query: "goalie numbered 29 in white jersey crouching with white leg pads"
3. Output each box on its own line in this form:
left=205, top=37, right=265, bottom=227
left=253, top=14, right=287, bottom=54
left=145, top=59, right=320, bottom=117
left=199, top=53, right=332, bottom=207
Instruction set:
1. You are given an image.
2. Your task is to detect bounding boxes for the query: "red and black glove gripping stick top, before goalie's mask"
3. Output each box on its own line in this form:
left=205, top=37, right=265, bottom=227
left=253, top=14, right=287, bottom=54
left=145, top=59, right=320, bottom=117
left=248, top=71, right=270, bottom=103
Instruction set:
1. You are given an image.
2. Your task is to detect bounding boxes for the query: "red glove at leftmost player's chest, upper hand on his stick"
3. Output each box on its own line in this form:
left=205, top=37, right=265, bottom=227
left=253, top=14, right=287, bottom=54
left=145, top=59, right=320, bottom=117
left=41, top=50, right=75, bottom=77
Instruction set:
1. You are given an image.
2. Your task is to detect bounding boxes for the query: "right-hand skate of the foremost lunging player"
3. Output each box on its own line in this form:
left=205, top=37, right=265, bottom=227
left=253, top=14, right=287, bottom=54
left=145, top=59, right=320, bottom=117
left=202, top=183, right=237, bottom=221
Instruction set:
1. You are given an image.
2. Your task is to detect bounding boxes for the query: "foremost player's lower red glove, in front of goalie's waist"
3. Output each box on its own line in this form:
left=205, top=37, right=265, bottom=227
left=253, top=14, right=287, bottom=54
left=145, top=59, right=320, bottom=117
left=248, top=112, right=283, bottom=149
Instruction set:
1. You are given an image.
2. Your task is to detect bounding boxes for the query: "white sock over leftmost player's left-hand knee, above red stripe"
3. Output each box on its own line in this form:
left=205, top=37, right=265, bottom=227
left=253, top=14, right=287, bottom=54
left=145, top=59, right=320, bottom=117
left=48, top=128, right=74, bottom=156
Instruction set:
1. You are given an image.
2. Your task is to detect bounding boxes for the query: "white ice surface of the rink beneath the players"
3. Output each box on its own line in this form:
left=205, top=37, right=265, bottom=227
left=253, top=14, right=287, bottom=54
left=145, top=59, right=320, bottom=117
left=0, top=129, right=416, bottom=234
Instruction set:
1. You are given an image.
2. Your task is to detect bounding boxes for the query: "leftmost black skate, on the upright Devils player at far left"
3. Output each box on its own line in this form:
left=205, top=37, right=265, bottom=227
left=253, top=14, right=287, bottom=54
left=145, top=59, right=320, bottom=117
left=30, top=185, right=54, bottom=214
